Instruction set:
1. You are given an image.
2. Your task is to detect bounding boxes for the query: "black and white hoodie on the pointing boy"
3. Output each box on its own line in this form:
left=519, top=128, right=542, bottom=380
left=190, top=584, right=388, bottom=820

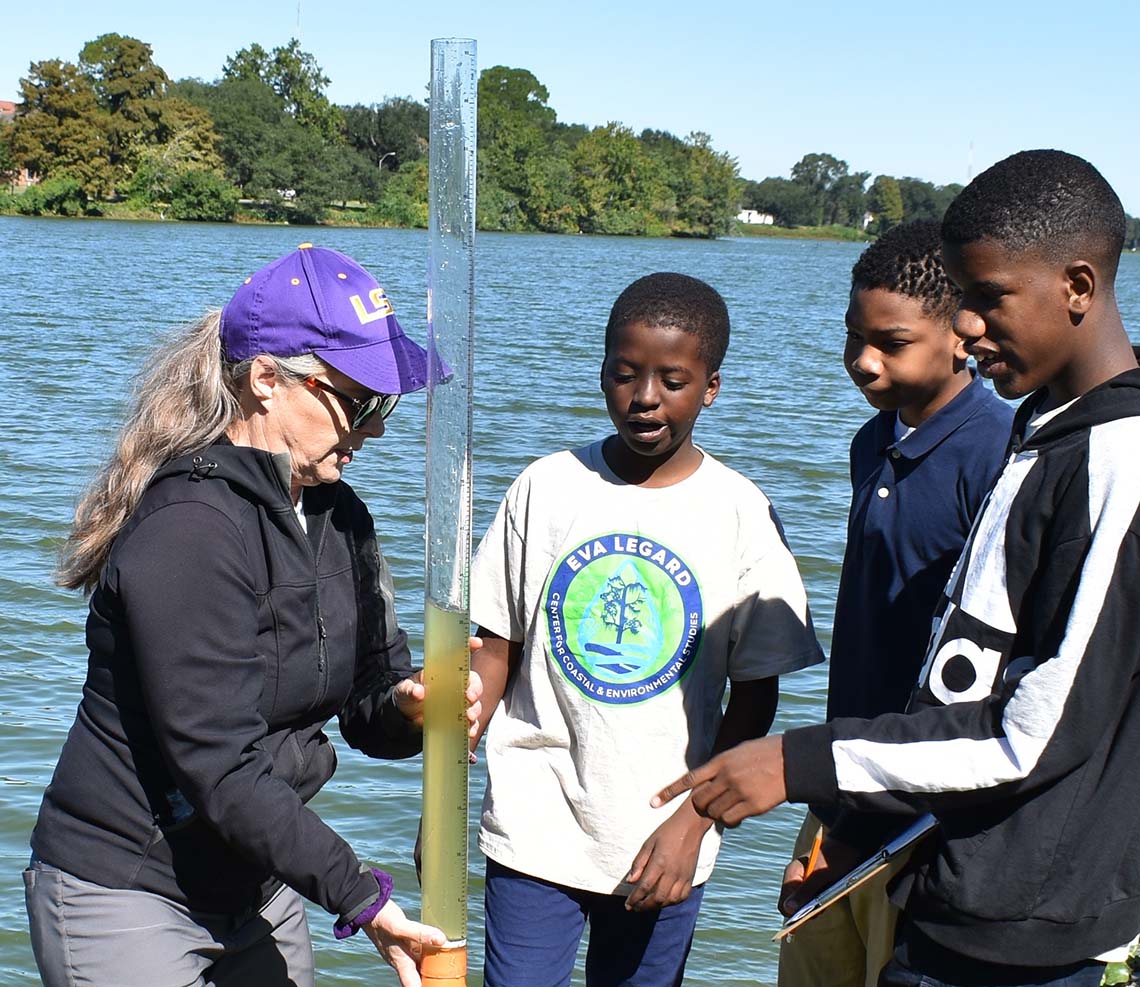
left=784, top=370, right=1140, bottom=966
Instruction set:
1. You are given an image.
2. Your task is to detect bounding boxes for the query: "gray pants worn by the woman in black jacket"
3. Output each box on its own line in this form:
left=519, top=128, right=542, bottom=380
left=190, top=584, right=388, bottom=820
left=24, top=860, right=316, bottom=987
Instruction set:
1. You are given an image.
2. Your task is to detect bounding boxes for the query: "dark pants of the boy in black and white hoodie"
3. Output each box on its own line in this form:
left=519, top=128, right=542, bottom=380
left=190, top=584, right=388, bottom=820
left=879, top=925, right=1105, bottom=987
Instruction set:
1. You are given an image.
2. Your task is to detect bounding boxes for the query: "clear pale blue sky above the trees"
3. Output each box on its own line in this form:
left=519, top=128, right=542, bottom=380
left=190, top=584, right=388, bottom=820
left=0, top=0, right=1140, bottom=215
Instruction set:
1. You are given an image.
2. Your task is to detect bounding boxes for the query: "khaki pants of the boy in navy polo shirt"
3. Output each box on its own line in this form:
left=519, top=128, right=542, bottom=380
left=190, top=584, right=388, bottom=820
left=777, top=813, right=907, bottom=987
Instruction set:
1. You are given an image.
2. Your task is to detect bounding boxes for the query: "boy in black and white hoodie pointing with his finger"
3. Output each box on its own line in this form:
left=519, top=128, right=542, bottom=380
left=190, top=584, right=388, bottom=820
left=654, top=150, right=1140, bottom=987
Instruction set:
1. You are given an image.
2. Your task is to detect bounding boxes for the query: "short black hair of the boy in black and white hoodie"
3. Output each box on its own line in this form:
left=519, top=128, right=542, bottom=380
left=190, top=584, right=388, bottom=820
left=942, top=150, right=1124, bottom=280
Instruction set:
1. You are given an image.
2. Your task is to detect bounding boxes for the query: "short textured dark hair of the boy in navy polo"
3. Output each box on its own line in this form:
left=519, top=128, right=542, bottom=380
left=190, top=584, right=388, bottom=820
left=852, top=220, right=962, bottom=324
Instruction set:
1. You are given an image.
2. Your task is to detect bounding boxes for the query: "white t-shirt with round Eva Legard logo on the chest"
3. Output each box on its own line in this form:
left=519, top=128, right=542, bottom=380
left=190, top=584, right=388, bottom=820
left=471, top=442, right=823, bottom=894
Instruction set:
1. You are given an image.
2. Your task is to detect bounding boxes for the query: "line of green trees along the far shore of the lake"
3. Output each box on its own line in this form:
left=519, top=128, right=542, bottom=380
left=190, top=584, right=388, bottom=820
left=0, top=34, right=1140, bottom=246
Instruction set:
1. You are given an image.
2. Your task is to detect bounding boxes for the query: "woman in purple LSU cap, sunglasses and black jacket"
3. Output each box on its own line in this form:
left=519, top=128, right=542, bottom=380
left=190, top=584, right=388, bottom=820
left=25, top=244, right=481, bottom=987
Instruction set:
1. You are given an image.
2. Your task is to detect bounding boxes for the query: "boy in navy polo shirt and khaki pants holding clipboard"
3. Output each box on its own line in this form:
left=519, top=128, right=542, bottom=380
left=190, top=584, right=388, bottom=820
left=779, top=221, right=1013, bottom=987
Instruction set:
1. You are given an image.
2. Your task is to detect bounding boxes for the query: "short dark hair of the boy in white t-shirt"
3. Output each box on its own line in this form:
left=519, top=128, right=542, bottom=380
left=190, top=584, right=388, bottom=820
left=605, top=271, right=728, bottom=374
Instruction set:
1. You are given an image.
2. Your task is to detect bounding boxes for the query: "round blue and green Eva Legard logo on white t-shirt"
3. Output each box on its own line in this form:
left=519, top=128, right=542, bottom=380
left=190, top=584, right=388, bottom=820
left=543, top=532, right=705, bottom=705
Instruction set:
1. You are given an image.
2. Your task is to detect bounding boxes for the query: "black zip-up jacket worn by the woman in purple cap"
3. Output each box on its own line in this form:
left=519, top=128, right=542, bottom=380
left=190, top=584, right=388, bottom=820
left=32, top=441, right=422, bottom=921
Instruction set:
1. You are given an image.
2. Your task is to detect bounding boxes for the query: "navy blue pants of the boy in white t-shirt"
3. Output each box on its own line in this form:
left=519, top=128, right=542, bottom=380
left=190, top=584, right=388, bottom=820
left=483, top=859, right=705, bottom=987
